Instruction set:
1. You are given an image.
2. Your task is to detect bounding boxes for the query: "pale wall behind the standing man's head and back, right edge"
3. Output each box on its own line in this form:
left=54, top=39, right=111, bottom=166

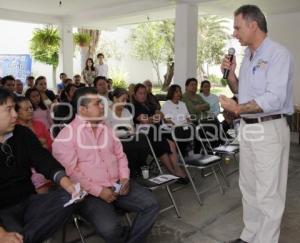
left=267, top=12, right=300, bottom=104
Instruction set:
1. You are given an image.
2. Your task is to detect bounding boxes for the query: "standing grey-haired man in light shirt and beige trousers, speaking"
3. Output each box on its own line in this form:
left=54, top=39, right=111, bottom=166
left=220, top=5, right=293, bottom=243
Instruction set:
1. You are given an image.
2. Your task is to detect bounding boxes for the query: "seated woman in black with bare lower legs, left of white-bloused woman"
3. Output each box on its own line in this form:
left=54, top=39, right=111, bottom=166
left=134, top=83, right=188, bottom=183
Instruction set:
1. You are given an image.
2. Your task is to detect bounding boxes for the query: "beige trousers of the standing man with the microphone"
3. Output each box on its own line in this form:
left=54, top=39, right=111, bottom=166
left=239, top=118, right=290, bottom=243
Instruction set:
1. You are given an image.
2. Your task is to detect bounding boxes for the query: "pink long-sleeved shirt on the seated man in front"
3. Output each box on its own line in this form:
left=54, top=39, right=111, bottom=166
left=52, top=115, right=129, bottom=197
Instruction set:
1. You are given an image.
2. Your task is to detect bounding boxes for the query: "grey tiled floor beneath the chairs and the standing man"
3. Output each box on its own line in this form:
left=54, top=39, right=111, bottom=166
left=51, top=134, right=300, bottom=243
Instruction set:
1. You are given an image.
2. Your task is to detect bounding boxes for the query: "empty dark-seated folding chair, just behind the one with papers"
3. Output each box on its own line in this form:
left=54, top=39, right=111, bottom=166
left=172, top=124, right=226, bottom=205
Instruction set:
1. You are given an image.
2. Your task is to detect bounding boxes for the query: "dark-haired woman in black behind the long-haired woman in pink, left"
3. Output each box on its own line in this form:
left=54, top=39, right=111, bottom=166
left=34, top=76, right=57, bottom=109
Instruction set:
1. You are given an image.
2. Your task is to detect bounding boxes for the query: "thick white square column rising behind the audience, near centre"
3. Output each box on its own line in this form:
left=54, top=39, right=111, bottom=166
left=174, top=3, right=198, bottom=87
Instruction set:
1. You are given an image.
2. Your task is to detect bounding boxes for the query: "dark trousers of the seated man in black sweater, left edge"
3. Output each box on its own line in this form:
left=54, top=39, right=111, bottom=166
left=0, top=189, right=74, bottom=243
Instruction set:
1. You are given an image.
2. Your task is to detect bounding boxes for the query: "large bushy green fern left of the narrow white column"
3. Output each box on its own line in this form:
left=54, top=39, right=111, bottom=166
left=30, top=25, right=61, bottom=87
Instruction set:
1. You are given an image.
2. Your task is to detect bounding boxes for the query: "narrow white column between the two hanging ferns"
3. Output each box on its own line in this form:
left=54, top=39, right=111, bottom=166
left=61, top=24, right=74, bottom=78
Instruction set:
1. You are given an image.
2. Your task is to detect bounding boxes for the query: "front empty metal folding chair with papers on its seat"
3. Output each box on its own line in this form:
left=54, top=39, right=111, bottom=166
left=135, top=129, right=181, bottom=218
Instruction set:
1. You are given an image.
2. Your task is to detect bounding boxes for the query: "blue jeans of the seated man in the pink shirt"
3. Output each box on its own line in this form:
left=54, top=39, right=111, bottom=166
left=78, top=182, right=159, bottom=243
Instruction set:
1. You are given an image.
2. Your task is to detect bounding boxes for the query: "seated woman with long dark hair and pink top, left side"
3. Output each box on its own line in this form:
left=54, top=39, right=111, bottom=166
left=25, top=88, right=53, bottom=130
